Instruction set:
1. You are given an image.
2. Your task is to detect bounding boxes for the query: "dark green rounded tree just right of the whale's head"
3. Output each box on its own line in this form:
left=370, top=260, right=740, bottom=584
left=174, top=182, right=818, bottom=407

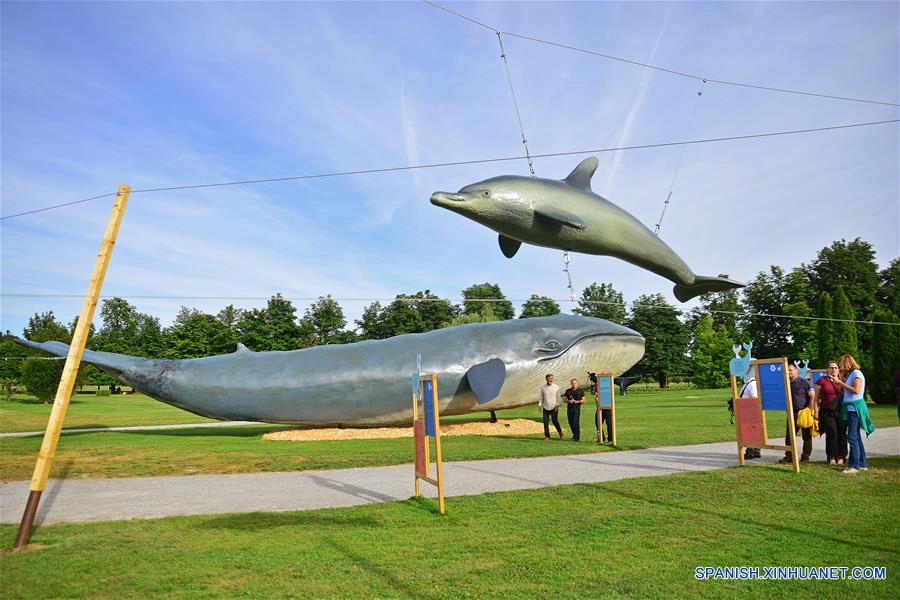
left=625, top=294, right=688, bottom=388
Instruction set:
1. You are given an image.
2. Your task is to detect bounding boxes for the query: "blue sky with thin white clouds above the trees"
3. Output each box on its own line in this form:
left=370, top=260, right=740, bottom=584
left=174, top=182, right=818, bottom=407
left=0, top=1, right=900, bottom=334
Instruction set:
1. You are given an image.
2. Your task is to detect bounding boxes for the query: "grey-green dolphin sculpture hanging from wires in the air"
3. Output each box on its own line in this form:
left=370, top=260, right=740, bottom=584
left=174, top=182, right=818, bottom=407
left=431, top=156, right=744, bottom=302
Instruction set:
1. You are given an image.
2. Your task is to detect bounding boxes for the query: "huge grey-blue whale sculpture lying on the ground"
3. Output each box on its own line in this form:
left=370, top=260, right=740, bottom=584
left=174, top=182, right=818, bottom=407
left=16, top=315, right=644, bottom=427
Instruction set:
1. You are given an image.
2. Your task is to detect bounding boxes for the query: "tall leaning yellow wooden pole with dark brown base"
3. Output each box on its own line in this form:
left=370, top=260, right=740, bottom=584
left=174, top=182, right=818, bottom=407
left=15, top=184, right=131, bottom=549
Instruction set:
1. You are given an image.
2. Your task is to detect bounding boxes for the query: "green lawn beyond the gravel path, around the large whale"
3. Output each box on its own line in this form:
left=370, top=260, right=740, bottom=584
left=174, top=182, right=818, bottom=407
left=0, top=390, right=897, bottom=481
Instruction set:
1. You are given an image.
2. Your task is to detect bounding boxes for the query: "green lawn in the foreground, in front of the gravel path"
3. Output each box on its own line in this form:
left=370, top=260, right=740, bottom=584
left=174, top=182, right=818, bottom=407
left=0, top=457, right=900, bottom=600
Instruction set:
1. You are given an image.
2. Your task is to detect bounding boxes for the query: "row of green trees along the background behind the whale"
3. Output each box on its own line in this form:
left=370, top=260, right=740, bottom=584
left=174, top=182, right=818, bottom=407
left=0, top=239, right=900, bottom=401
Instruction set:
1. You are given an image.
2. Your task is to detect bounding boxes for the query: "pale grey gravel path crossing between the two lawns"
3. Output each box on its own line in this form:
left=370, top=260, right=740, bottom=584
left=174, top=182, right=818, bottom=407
left=0, top=427, right=900, bottom=523
